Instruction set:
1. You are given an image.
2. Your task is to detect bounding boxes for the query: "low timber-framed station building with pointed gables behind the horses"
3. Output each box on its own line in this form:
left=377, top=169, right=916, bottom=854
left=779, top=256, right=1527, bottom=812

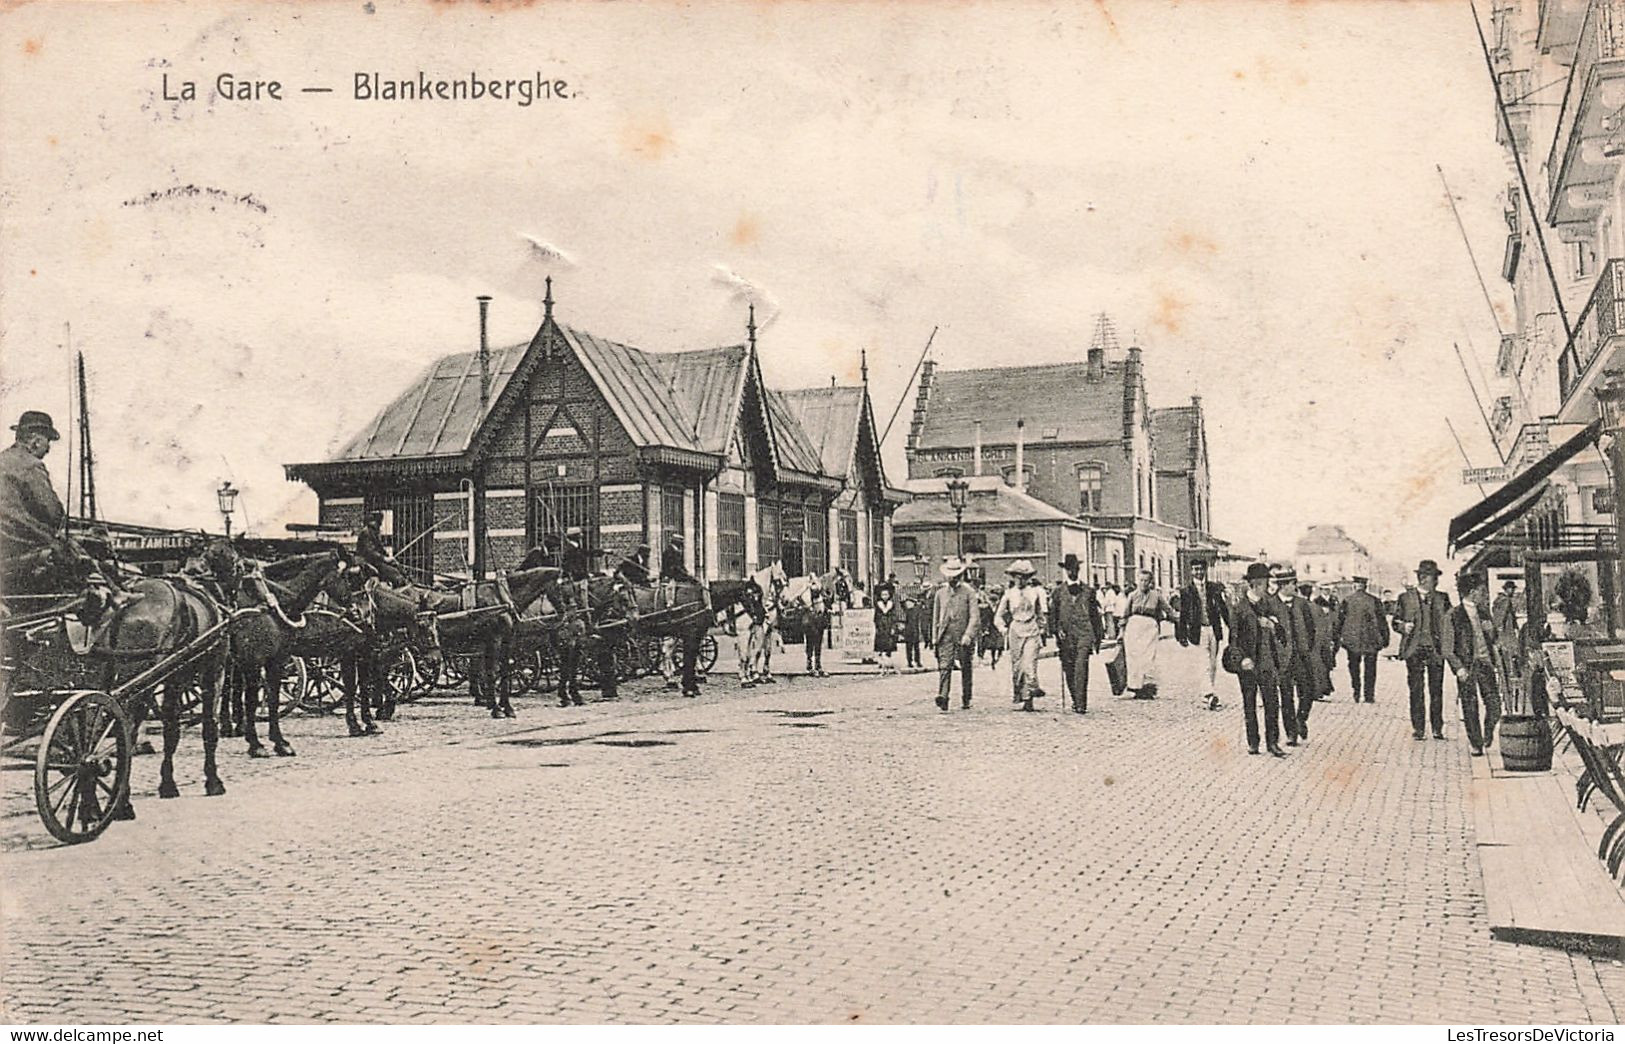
left=284, top=280, right=907, bottom=582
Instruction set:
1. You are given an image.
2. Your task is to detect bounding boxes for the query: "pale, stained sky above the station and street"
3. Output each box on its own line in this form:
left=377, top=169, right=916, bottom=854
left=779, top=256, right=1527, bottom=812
left=0, top=0, right=1510, bottom=561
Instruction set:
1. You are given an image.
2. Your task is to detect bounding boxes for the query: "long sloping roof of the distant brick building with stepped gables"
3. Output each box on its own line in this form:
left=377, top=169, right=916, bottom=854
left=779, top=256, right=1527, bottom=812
left=915, top=361, right=1128, bottom=449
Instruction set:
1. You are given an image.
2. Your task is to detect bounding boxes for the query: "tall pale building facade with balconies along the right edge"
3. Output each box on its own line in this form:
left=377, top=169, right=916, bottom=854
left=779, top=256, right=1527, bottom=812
left=1451, top=0, right=1625, bottom=548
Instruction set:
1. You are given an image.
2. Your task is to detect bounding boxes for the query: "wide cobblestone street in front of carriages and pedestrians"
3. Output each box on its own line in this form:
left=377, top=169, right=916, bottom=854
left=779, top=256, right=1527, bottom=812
left=0, top=641, right=1625, bottom=1024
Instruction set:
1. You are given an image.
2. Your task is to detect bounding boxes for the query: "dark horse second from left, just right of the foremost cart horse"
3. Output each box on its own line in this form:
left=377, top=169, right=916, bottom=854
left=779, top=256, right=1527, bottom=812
left=203, top=542, right=340, bottom=758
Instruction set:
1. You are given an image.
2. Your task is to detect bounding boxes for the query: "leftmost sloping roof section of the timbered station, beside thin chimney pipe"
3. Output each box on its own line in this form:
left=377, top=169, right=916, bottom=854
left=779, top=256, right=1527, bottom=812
left=332, top=345, right=527, bottom=462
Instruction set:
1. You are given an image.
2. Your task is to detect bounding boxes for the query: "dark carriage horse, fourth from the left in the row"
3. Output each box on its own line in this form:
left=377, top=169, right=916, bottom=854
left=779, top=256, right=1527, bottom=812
left=405, top=566, right=559, bottom=717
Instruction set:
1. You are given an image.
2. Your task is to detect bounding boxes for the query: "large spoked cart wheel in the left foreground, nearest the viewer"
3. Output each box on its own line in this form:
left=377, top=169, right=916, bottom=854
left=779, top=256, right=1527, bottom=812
left=34, top=693, right=130, bottom=844
